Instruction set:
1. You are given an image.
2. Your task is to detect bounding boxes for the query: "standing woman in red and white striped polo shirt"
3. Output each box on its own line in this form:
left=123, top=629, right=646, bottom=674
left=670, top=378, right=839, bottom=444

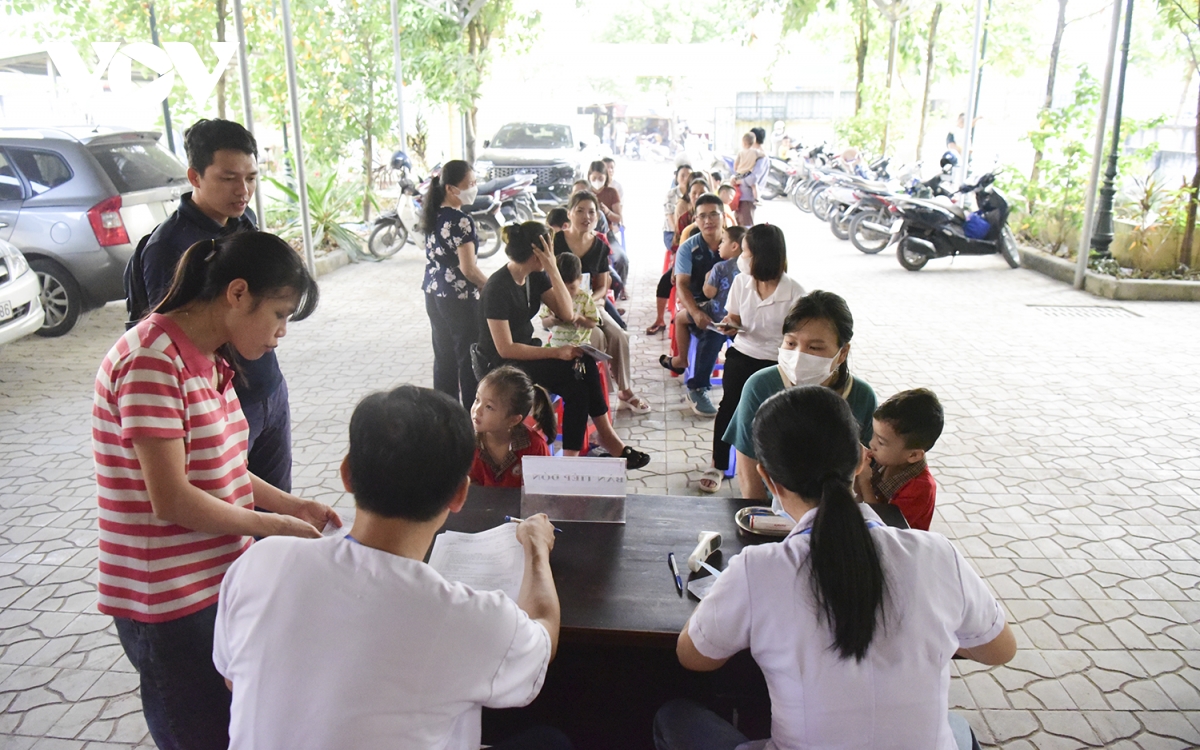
left=92, top=232, right=341, bottom=750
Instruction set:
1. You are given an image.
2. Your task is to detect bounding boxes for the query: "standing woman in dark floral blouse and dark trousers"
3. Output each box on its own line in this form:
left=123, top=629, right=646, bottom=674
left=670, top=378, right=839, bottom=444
left=421, top=160, right=487, bottom=409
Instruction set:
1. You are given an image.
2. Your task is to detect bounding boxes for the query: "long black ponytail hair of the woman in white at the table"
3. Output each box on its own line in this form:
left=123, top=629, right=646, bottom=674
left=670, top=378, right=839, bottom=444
left=754, top=385, right=887, bottom=661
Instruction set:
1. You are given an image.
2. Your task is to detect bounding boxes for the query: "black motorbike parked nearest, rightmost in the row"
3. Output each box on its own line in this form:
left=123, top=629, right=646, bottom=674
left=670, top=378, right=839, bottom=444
left=889, top=173, right=1021, bottom=271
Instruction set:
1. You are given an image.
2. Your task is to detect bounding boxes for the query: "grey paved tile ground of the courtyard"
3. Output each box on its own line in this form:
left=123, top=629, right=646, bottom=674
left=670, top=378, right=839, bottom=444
left=0, top=164, right=1200, bottom=750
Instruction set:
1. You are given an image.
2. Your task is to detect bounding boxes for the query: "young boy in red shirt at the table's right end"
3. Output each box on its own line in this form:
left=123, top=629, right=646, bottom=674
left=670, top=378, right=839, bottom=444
left=854, top=388, right=946, bottom=532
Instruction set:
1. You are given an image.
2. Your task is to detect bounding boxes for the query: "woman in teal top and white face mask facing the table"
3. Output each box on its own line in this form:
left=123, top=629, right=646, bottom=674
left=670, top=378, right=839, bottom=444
left=724, top=290, right=878, bottom=499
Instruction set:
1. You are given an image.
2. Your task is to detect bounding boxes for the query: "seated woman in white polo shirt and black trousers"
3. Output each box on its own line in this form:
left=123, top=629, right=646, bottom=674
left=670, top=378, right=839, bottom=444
left=700, top=224, right=804, bottom=493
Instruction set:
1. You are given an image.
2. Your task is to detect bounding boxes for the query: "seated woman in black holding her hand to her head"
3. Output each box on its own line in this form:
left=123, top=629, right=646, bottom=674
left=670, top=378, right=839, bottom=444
left=479, top=221, right=650, bottom=469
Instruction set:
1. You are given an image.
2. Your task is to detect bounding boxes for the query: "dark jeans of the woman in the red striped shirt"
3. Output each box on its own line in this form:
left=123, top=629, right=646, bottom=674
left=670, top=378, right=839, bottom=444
left=113, top=605, right=232, bottom=750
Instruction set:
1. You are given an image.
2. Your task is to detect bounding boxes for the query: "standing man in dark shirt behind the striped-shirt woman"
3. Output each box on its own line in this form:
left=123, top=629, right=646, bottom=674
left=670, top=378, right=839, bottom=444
left=140, top=120, right=292, bottom=492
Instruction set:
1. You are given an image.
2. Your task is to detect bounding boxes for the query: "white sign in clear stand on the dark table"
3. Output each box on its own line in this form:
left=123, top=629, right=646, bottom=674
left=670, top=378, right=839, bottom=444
left=521, top=456, right=625, bottom=523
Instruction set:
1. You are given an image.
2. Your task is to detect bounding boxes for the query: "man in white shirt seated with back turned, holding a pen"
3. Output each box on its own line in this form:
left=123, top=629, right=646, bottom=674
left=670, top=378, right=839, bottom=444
left=212, top=385, right=570, bottom=750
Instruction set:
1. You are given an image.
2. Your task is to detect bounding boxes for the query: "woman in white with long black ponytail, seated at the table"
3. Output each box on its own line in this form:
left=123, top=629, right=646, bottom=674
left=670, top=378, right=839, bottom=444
left=654, top=386, right=1016, bottom=750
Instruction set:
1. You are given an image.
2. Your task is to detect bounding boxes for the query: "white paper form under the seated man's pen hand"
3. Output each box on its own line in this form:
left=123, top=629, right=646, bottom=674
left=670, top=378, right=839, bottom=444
left=430, top=523, right=524, bottom=601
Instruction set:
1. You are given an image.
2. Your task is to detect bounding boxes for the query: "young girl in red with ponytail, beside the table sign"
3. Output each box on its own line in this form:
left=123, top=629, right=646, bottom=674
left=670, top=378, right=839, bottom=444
left=470, top=365, right=558, bottom=487
